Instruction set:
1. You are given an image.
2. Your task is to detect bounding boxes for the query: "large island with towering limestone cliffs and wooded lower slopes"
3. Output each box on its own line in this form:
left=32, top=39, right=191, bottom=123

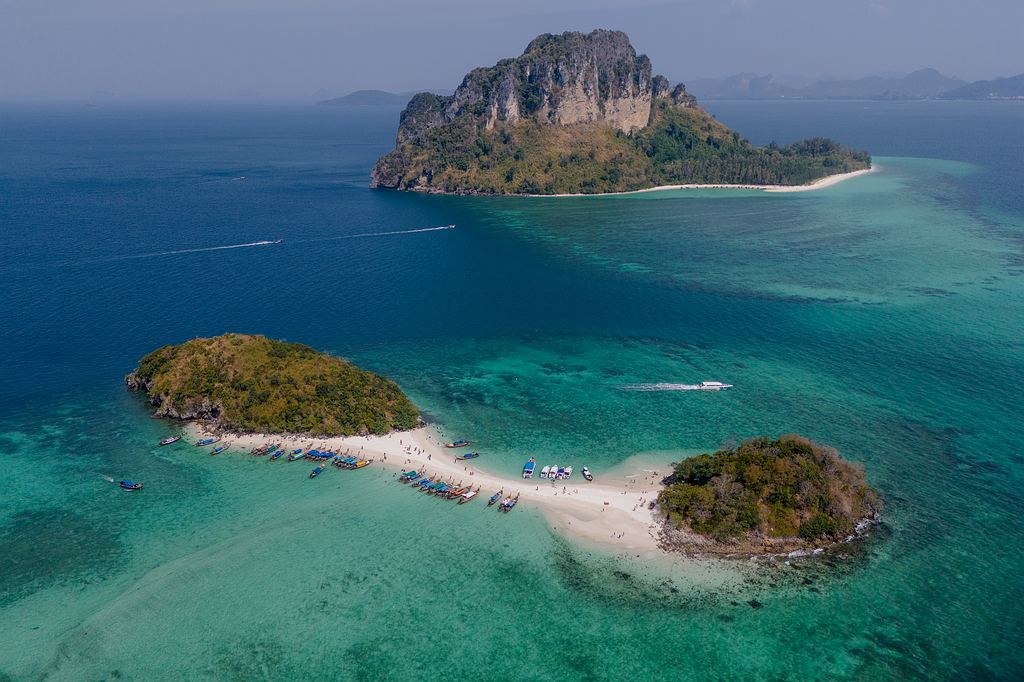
left=371, top=31, right=871, bottom=195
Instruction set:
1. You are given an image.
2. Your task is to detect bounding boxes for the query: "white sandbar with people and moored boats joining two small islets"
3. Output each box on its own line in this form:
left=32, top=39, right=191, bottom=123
left=187, top=424, right=669, bottom=554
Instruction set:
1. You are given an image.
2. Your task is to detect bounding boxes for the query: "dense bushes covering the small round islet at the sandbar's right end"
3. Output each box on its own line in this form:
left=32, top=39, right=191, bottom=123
left=658, top=435, right=880, bottom=544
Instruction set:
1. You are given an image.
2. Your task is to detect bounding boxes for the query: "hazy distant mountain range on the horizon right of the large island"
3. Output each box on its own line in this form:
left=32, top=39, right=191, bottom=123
left=686, top=69, right=1024, bottom=99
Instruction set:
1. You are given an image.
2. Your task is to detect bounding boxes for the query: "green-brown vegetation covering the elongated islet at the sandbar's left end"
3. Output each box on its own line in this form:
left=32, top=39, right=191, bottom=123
left=126, top=334, right=419, bottom=436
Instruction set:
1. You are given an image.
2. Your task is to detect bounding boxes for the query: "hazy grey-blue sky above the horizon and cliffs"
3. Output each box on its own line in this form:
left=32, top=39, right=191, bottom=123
left=0, top=0, right=1024, bottom=99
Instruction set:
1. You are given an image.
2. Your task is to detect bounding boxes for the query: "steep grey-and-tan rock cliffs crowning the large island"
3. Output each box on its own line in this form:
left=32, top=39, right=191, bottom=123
left=371, top=30, right=695, bottom=188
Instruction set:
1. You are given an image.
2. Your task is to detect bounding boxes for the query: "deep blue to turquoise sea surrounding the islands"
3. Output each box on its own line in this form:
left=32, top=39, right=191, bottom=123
left=0, top=102, right=1024, bottom=679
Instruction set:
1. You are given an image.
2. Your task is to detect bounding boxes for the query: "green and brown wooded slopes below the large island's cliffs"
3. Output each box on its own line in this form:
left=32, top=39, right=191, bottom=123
left=385, top=102, right=870, bottom=195
